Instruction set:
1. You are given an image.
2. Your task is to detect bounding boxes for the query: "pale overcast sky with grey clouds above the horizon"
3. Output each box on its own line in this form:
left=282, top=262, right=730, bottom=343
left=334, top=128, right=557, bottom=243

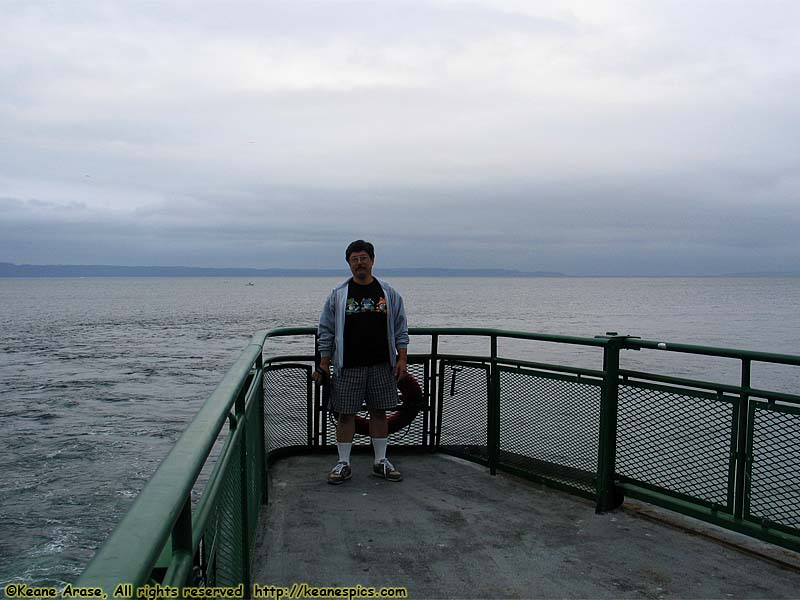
left=0, top=0, right=800, bottom=275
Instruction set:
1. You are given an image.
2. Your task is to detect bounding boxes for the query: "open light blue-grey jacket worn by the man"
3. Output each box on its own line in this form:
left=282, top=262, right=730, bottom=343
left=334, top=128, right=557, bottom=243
left=317, top=277, right=408, bottom=373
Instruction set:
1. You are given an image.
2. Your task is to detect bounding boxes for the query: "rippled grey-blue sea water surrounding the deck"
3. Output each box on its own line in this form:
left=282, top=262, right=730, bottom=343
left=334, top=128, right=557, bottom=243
left=0, top=278, right=800, bottom=585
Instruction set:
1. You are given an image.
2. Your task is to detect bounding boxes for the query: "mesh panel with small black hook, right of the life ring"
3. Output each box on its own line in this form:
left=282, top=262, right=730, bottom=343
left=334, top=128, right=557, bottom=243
left=439, top=361, right=489, bottom=459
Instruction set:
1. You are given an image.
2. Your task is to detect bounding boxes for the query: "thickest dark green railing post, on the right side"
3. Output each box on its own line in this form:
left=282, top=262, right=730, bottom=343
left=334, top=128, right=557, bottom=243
left=595, top=333, right=626, bottom=513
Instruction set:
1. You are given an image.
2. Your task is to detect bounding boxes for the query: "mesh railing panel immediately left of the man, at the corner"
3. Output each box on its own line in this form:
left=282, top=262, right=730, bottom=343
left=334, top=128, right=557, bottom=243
left=264, top=365, right=312, bottom=453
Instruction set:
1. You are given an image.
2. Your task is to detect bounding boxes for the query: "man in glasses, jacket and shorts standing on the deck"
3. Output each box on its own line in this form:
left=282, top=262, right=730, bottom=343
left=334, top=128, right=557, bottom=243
left=313, top=240, right=408, bottom=484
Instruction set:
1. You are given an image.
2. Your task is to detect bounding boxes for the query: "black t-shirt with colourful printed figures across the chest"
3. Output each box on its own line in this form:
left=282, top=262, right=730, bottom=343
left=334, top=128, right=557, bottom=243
left=344, top=279, right=389, bottom=368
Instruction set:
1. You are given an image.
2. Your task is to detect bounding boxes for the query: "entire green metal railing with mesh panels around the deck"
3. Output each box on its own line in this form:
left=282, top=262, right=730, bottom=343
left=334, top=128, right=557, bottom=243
left=77, top=327, right=800, bottom=597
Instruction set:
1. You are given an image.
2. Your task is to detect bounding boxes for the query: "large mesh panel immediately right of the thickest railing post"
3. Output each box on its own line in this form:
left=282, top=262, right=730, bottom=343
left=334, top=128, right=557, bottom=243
left=616, top=382, right=738, bottom=512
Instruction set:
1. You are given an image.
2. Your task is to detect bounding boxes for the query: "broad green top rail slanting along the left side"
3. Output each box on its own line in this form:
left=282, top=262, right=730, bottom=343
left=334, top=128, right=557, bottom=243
left=78, top=343, right=263, bottom=590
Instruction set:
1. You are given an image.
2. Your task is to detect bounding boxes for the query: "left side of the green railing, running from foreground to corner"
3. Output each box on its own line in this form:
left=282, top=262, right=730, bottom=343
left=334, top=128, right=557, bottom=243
left=76, top=332, right=266, bottom=598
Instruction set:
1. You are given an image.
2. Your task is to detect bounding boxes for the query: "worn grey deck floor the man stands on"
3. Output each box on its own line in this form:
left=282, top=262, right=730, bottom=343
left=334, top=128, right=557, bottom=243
left=253, top=448, right=800, bottom=600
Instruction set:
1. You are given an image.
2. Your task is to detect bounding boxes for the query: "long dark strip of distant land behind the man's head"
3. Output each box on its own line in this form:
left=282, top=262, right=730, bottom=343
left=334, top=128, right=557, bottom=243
left=0, top=263, right=566, bottom=277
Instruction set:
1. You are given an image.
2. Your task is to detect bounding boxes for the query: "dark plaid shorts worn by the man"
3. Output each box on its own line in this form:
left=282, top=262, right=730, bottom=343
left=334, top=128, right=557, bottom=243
left=331, top=363, right=398, bottom=415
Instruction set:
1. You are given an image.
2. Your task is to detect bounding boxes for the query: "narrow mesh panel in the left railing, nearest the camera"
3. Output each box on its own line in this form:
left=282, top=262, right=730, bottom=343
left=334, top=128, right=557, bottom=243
left=203, top=437, right=244, bottom=586
